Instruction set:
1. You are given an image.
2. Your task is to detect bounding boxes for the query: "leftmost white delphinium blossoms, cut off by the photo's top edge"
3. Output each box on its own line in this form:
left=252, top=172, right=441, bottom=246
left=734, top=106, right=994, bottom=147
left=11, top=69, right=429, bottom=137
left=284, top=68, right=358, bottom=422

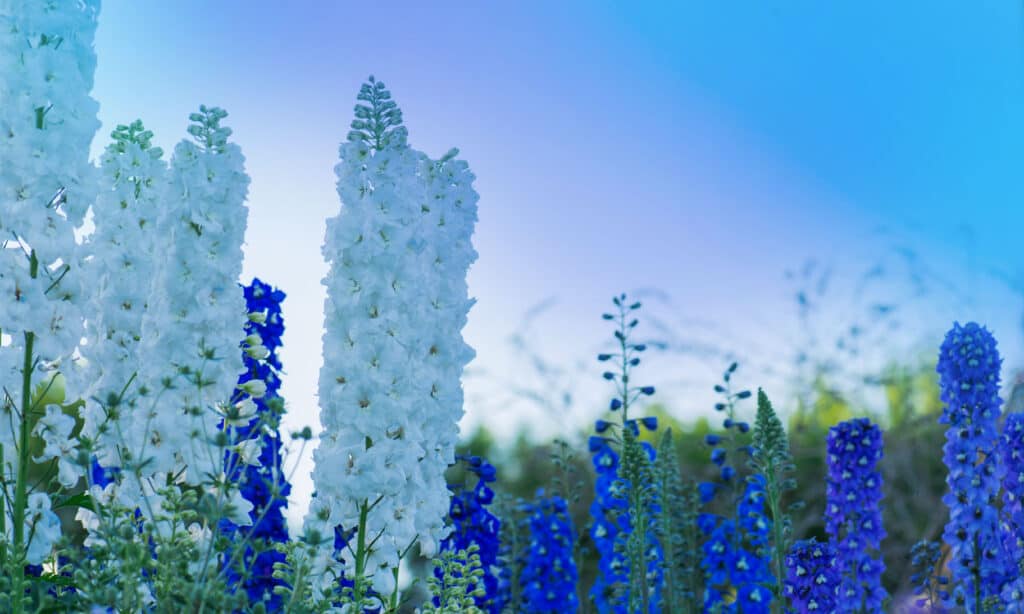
left=0, top=0, right=99, bottom=563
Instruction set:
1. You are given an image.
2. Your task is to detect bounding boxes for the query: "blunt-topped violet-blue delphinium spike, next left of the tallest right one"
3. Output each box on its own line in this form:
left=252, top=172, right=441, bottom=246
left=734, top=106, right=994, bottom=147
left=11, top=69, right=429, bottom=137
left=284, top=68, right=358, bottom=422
left=825, top=418, right=887, bottom=614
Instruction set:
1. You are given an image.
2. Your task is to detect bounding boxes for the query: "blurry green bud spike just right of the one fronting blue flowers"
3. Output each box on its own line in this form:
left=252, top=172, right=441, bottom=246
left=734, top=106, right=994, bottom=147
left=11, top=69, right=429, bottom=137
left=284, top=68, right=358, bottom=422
left=653, top=429, right=703, bottom=614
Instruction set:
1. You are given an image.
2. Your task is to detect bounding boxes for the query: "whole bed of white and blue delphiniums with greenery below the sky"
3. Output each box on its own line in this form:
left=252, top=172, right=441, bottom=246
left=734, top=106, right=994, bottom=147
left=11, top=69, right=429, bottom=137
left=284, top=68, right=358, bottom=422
left=0, top=0, right=1024, bottom=614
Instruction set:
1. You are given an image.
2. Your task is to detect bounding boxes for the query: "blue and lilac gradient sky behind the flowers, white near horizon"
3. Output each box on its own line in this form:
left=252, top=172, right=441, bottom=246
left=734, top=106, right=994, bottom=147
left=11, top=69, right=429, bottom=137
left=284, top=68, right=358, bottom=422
left=93, top=0, right=1024, bottom=521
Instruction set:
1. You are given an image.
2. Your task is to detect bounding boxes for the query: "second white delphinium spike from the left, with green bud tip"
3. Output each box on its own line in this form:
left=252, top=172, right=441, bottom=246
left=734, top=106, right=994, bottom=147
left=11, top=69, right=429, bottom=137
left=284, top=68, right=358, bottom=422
left=79, top=121, right=167, bottom=467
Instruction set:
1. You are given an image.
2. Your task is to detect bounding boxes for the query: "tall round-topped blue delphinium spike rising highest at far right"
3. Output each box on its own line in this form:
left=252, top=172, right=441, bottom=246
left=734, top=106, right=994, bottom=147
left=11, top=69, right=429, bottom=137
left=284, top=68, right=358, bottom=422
left=936, top=322, right=1009, bottom=611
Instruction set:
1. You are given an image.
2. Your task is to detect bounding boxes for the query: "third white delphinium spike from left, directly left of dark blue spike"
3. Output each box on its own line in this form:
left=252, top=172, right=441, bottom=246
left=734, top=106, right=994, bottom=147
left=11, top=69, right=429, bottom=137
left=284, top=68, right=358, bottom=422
left=130, top=106, right=249, bottom=484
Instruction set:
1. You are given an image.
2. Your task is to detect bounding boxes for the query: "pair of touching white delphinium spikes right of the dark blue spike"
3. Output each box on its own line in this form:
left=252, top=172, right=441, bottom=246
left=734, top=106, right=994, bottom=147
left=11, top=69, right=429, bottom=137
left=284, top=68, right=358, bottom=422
left=306, top=78, right=477, bottom=595
